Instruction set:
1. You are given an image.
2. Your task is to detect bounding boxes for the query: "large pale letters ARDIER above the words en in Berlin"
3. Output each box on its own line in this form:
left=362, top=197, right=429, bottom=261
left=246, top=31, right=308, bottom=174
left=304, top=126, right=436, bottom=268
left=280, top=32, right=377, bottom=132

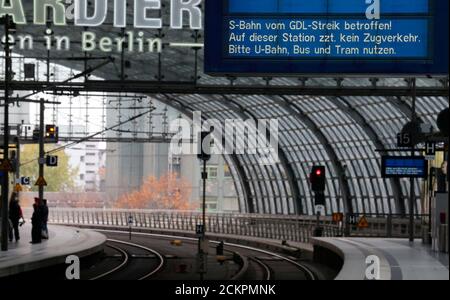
left=0, top=0, right=202, bottom=29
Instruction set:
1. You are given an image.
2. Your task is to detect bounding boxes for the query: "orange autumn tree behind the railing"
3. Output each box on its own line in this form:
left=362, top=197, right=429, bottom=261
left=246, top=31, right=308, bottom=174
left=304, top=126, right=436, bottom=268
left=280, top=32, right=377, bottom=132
left=115, top=172, right=196, bottom=210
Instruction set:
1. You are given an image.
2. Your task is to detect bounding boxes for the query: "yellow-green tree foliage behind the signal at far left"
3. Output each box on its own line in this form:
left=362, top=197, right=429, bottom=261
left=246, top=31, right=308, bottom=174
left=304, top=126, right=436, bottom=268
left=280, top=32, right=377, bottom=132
left=20, top=145, right=78, bottom=192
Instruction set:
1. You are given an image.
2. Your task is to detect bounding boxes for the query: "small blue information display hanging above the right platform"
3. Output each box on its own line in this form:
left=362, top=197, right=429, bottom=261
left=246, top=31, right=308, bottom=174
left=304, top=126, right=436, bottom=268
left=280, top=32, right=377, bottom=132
left=381, top=156, right=428, bottom=178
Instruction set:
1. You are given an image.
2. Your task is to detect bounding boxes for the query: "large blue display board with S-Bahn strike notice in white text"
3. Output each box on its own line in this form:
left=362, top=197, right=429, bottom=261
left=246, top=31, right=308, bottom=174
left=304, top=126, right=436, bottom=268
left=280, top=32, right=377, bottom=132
left=205, top=0, right=449, bottom=75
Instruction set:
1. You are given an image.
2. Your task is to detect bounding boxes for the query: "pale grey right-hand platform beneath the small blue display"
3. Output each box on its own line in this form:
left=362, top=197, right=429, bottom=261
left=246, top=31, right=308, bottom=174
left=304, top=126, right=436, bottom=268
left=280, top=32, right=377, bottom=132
left=312, top=238, right=449, bottom=280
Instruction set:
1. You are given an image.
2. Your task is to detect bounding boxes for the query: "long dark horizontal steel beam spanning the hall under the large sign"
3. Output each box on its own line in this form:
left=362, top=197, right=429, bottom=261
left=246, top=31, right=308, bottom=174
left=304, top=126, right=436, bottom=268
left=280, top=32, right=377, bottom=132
left=0, top=80, right=449, bottom=97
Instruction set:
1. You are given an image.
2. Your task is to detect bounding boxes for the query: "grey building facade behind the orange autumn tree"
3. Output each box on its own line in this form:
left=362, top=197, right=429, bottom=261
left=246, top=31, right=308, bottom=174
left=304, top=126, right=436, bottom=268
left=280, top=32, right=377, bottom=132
left=105, top=99, right=239, bottom=212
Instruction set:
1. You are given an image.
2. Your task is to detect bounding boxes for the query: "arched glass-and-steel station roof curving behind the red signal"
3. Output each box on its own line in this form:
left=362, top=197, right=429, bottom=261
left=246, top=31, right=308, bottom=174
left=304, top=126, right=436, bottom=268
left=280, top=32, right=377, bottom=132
left=2, top=1, right=449, bottom=214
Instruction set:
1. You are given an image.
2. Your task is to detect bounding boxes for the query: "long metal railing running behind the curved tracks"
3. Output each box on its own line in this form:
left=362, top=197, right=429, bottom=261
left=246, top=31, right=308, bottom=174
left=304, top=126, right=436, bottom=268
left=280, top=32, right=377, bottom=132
left=25, top=208, right=423, bottom=243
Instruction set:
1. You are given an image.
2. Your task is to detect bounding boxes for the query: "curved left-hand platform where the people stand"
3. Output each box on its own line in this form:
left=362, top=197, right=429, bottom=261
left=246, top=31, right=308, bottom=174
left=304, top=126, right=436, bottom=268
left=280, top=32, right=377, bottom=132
left=0, top=224, right=106, bottom=278
